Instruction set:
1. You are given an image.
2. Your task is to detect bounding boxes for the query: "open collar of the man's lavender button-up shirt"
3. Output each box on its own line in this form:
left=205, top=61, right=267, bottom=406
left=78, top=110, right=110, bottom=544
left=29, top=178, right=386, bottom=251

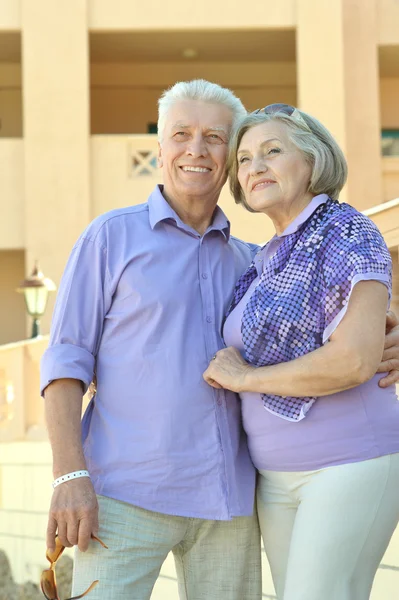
left=148, top=185, right=230, bottom=241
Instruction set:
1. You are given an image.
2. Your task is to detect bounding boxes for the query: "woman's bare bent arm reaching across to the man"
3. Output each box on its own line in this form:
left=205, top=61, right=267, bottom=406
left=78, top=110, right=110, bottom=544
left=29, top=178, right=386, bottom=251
left=204, top=281, right=388, bottom=397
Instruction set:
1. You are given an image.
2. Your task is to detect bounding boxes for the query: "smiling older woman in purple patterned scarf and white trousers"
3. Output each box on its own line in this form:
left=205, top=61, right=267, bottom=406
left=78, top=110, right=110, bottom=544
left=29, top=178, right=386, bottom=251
left=204, top=105, right=399, bottom=600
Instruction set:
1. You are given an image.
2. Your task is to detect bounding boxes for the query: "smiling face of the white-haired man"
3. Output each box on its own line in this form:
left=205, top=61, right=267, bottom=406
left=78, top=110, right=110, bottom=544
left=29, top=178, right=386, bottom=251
left=159, top=100, right=233, bottom=203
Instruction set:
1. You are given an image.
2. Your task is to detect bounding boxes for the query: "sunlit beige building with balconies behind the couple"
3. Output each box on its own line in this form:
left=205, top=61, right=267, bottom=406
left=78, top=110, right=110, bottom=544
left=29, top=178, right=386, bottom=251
left=0, top=0, right=399, bottom=592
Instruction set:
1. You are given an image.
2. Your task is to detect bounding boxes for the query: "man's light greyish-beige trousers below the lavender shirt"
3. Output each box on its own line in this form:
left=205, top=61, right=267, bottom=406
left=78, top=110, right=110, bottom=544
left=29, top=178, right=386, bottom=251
left=72, top=496, right=262, bottom=600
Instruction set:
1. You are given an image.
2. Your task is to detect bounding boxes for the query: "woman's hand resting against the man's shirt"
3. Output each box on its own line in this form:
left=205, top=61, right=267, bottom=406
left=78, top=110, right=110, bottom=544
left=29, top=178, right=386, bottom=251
left=203, top=346, right=255, bottom=392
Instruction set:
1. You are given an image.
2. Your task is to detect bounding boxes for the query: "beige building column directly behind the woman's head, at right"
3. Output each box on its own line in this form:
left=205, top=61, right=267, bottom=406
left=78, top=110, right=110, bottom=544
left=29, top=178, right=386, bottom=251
left=297, top=0, right=382, bottom=210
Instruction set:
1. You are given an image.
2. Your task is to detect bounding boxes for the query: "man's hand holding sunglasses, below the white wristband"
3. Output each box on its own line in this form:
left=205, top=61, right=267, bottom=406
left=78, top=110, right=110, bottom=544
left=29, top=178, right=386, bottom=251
left=47, top=477, right=98, bottom=552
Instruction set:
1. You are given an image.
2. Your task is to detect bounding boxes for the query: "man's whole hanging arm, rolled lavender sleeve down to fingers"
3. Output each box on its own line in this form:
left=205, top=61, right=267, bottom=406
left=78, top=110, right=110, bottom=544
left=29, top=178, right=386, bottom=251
left=40, top=232, right=112, bottom=550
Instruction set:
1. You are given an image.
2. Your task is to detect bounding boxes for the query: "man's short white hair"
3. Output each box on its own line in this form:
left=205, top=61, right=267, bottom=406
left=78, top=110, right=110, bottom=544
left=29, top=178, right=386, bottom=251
left=158, top=79, right=247, bottom=142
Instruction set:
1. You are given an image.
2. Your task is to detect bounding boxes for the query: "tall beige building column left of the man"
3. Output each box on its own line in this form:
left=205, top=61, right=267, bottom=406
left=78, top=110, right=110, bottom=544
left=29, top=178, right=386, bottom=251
left=21, top=0, right=90, bottom=333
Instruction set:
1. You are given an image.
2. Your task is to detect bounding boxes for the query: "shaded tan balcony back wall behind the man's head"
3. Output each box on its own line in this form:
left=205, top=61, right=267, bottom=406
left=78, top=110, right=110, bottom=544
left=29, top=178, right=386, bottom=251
left=91, top=61, right=296, bottom=134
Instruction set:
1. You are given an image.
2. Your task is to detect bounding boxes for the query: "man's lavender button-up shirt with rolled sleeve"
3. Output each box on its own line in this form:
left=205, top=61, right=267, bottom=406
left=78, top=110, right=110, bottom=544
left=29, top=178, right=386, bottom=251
left=41, top=188, right=255, bottom=520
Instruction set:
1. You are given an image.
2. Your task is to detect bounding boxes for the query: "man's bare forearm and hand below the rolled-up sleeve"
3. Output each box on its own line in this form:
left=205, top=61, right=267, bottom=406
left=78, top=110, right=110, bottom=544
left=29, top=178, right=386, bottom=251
left=44, top=379, right=98, bottom=552
